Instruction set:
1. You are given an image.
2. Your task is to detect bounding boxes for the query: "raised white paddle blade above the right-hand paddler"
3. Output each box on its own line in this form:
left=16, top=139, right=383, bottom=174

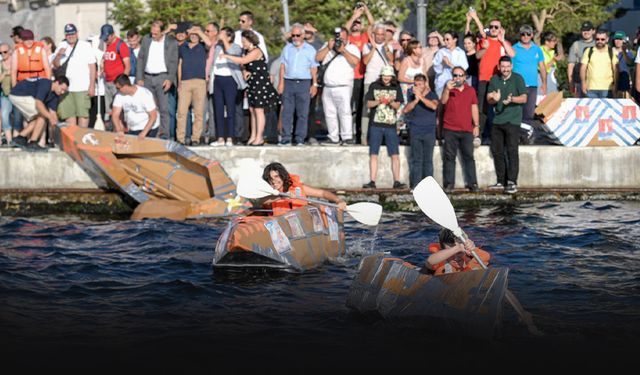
left=413, top=176, right=461, bottom=236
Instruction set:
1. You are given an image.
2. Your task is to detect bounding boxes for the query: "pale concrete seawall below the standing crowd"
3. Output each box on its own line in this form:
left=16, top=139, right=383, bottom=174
left=0, top=146, right=640, bottom=190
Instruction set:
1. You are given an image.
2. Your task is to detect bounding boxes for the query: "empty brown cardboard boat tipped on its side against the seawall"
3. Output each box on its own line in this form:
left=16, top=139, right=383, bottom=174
left=56, top=124, right=249, bottom=219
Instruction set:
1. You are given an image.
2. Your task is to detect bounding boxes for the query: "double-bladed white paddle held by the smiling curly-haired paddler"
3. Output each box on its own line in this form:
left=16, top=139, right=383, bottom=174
left=236, top=176, right=382, bottom=225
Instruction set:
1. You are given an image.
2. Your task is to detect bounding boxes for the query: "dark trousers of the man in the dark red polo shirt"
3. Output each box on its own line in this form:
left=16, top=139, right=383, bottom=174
left=442, top=129, right=478, bottom=187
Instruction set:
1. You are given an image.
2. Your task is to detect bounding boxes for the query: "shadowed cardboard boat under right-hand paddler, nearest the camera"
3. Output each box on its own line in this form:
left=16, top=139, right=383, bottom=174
left=347, top=254, right=508, bottom=338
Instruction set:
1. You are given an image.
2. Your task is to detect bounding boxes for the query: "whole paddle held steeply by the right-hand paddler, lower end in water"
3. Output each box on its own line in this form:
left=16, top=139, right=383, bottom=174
left=413, top=176, right=541, bottom=335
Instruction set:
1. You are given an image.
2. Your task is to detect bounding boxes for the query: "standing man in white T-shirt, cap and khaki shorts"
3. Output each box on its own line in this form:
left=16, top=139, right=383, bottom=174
left=52, top=23, right=97, bottom=128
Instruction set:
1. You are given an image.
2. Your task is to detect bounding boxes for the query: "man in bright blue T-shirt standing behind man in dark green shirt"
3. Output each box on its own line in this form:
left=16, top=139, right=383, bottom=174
left=512, top=25, right=547, bottom=125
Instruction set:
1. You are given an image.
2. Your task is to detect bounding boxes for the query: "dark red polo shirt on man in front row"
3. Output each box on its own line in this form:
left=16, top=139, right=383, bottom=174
left=442, top=83, right=478, bottom=133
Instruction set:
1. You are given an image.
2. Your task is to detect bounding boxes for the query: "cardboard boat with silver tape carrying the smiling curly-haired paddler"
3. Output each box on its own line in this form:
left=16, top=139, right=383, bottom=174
left=213, top=205, right=345, bottom=272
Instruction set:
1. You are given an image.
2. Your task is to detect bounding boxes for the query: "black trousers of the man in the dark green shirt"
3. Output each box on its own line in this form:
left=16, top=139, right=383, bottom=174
left=491, top=124, right=520, bottom=186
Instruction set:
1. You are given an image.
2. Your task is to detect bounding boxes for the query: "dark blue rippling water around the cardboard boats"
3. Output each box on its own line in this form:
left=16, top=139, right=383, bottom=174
left=0, top=202, right=640, bottom=369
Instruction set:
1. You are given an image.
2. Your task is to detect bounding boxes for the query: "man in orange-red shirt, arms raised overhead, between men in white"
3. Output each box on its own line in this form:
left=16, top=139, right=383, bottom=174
left=344, top=3, right=375, bottom=144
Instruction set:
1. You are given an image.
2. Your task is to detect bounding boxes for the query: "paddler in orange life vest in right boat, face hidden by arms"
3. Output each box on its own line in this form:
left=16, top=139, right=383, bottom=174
left=426, top=228, right=491, bottom=275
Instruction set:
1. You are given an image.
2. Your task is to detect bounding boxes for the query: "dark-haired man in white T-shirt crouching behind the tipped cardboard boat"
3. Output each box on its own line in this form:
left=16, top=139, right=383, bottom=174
left=113, top=74, right=160, bottom=140
